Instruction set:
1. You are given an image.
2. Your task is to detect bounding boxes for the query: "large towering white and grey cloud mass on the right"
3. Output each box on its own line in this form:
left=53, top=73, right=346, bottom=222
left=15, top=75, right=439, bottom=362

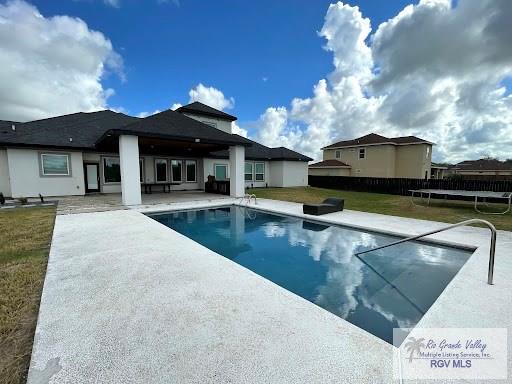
left=256, top=0, right=512, bottom=161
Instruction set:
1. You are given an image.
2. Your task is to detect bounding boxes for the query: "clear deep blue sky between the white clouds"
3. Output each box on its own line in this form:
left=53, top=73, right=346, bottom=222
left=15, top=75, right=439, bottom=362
left=32, top=0, right=416, bottom=123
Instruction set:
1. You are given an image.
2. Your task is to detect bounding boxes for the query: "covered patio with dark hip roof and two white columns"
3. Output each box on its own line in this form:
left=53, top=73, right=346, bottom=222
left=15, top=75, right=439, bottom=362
left=95, top=111, right=251, bottom=206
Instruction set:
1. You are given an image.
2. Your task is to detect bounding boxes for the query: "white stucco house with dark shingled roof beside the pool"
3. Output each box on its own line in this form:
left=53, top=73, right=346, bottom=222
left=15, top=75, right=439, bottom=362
left=0, top=102, right=311, bottom=205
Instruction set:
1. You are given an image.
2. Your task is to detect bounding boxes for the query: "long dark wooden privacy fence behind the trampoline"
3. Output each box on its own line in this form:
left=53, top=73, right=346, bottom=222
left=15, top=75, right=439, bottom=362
left=309, top=175, right=512, bottom=196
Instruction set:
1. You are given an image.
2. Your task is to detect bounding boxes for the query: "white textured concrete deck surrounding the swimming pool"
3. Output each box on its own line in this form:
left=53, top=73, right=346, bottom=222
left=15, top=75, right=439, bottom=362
left=28, top=199, right=512, bottom=384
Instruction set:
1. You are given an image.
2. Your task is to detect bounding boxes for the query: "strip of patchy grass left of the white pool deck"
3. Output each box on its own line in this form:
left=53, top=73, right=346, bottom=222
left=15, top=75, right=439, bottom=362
left=0, top=207, right=55, bottom=384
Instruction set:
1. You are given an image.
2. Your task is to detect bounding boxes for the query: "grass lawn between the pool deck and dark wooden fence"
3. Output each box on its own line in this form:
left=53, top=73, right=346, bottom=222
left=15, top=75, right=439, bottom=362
left=248, top=187, right=512, bottom=231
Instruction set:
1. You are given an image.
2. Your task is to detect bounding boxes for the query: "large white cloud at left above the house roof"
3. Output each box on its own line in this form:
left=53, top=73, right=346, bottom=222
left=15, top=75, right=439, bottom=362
left=0, top=0, right=124, bottom=121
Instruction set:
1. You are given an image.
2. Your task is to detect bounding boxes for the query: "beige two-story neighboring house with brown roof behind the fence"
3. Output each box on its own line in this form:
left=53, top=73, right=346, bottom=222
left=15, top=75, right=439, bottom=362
left=309, top=133, right=433, bottom=179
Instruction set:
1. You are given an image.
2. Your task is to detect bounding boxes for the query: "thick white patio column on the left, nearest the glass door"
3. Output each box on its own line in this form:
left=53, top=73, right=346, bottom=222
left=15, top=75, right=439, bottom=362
left=119, top=135, right=142, bottom=205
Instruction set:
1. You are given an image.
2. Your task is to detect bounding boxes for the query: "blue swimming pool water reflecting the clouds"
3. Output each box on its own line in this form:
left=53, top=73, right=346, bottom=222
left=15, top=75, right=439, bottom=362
left=151, top=206, right=471, bottom=343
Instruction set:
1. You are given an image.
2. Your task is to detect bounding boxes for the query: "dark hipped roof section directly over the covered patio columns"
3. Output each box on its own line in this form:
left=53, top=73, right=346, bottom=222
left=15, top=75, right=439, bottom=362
left=98, top=109, right=251, bottom=146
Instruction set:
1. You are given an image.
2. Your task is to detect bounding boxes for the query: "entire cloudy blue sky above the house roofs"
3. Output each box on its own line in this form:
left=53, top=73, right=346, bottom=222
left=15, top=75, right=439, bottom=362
left=0, top=0, right=512, bottom=162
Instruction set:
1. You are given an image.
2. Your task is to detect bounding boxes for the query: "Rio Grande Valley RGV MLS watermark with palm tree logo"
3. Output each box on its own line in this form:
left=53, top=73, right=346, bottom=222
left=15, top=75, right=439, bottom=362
left=393, top=328, right=507, bottom=380
